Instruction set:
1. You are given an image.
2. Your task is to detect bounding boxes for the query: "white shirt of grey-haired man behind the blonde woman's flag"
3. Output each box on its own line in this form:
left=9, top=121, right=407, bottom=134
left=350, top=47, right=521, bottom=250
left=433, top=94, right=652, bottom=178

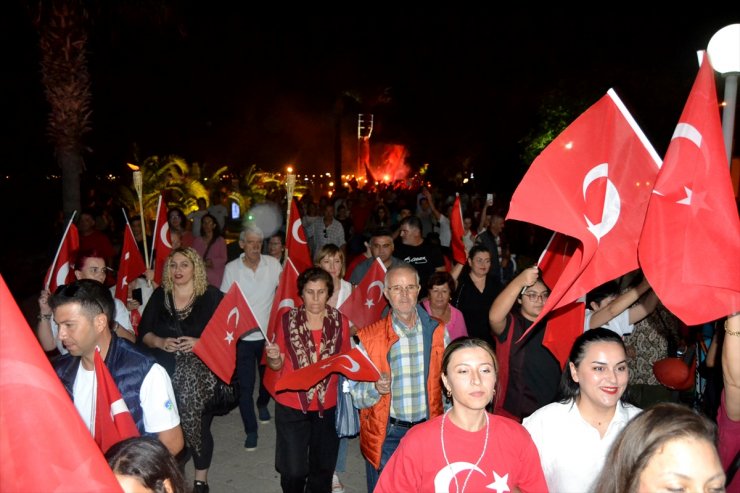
left=221, top=253, right=283, bottom=341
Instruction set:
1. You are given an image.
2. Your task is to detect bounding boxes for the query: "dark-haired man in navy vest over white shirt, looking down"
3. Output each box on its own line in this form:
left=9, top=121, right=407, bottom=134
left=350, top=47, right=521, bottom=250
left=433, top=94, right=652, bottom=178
left=49, top=279, right=184, bottom=455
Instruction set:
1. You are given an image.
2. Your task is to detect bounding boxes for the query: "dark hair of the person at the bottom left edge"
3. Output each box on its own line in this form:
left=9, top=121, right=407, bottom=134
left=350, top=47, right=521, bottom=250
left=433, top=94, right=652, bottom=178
left=105, top=436, right=189, bottom=493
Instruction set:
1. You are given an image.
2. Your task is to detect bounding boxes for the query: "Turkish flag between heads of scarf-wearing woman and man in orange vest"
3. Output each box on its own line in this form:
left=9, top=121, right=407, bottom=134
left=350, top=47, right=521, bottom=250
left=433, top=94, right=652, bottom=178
left=338, top=257, right=388, bottom=328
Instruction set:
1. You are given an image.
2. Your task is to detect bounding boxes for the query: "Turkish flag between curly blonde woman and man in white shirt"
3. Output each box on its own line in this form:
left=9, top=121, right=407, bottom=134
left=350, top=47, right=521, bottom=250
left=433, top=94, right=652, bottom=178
left=193, top=282, right=259, bottom=383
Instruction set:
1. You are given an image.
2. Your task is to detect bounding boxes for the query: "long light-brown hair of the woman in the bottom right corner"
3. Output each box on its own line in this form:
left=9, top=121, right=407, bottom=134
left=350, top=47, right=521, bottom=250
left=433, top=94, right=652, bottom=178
left=593, top=402, right=717, bottom=493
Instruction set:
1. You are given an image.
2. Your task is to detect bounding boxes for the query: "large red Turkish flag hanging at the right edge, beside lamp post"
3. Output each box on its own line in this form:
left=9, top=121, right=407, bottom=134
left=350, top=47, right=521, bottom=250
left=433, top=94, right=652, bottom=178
left=639, top=53, right=740, bottom=325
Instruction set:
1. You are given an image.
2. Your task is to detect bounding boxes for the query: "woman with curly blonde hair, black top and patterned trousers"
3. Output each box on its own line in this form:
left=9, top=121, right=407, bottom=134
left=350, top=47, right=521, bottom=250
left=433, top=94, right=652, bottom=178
left=139, top=247, right=223, bottom=493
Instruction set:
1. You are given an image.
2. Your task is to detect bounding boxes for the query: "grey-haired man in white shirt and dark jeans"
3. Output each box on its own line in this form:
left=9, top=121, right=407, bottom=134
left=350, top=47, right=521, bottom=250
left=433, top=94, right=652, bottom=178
left=221, top=226, right=283, bottom=452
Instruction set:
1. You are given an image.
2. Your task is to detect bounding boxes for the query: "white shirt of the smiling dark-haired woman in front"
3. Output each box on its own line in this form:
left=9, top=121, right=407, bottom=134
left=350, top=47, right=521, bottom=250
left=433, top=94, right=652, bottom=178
left=522, top=401, right=642, bottom=493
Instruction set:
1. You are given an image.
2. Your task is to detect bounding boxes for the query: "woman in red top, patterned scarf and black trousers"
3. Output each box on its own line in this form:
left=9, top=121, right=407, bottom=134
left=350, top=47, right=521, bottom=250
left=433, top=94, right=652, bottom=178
left=265, top=267, right=350, bottom=493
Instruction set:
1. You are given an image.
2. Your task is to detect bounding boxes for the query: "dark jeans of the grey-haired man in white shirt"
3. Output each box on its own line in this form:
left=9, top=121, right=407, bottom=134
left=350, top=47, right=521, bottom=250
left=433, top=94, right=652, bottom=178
left=236, top=339, right=270, bottom=433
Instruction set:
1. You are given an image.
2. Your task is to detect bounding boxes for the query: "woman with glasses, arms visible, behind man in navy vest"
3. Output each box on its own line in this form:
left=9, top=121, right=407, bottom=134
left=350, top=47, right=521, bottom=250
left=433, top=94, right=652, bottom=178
left=36, top=250, right=136, bottom=354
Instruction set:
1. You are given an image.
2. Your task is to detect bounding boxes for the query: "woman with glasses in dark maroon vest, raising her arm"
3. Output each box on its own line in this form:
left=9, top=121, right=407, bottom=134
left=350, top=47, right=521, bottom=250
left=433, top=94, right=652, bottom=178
left=488, top=266, right=561, bottom=421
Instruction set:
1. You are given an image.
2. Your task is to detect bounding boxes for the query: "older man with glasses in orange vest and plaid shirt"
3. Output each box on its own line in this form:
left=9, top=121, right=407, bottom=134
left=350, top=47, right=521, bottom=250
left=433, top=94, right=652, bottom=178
left=352, top=264, right=449, bottom=493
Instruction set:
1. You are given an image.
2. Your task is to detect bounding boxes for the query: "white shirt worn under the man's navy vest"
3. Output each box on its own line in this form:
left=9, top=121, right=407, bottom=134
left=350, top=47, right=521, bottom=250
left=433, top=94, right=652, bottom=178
left=72, top=362, right=180, bottom=434
